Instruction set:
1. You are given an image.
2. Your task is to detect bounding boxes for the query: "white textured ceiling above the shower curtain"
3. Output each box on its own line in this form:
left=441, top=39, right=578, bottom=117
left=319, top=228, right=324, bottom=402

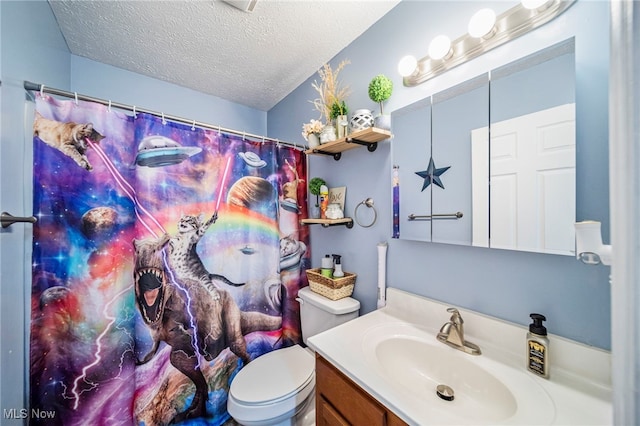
left=49, top=0, right=400, bottom=111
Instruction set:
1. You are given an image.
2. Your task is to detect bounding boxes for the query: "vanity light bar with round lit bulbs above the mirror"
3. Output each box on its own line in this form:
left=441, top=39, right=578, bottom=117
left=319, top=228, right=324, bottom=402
left=398, top=0, right=576, bottom=87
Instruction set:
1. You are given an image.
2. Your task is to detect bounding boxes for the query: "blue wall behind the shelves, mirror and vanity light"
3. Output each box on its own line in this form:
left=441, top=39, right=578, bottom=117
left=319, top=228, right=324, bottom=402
left=268, top=0, right=611, bottom=349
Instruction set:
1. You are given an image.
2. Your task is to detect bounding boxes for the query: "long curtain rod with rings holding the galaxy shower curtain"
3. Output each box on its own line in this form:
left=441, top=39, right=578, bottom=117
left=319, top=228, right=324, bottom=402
left=24, top=80, right=305, bottom=151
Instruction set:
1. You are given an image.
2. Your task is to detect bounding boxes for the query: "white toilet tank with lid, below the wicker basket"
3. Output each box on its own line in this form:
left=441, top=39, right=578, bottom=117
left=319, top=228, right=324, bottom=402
left=296, top=287, right=360, bottom=344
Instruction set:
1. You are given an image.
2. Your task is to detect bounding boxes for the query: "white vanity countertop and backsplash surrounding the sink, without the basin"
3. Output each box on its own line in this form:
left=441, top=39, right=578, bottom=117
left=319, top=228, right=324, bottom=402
left=308, top=288, right=613, bottom=425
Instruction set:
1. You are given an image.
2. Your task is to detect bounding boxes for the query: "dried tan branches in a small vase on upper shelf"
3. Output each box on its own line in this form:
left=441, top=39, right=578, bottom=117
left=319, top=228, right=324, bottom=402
left=311, top=60, right=351, bottom=142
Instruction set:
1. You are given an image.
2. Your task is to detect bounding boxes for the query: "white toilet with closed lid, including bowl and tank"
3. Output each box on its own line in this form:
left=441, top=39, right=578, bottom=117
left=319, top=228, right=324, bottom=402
left=227, top=287, right=360, bottom=426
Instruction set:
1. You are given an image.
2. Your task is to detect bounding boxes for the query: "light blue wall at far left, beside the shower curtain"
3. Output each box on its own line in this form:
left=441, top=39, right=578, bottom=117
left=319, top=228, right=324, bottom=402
left=0, top=1, right=70, bottom=412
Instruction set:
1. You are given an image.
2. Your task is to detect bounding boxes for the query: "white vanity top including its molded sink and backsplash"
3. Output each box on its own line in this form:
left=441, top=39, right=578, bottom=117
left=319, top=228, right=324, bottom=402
left=308, top=288, right=613, bottom=425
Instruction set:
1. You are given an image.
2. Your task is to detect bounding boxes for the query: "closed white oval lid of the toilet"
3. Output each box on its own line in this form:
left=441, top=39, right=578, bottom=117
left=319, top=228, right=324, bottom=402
left=229, top=345, right=315, bottom=405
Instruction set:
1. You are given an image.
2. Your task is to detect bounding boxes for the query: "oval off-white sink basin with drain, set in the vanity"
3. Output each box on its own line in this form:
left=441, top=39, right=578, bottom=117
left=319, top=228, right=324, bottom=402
left=363, top=323, right=555, bottom=424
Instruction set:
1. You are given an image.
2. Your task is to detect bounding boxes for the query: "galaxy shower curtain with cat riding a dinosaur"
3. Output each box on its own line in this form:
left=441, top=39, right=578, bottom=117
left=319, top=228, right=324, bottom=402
left=30, top=96, right=309, bottom=426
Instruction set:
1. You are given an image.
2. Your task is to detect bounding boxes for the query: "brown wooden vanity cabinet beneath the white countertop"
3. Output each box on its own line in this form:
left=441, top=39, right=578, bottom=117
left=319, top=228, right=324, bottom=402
left=316, top=354, right=406, bottom=426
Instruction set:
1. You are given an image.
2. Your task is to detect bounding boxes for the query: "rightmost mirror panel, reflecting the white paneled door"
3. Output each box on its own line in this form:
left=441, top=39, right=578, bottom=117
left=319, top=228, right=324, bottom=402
left=489, top=39, right=576, bottom=255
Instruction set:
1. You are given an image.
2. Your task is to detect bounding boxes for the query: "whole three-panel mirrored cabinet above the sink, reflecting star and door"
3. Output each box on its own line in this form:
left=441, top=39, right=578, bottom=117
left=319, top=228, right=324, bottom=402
left=392, top=39, right=576, bottom=255
